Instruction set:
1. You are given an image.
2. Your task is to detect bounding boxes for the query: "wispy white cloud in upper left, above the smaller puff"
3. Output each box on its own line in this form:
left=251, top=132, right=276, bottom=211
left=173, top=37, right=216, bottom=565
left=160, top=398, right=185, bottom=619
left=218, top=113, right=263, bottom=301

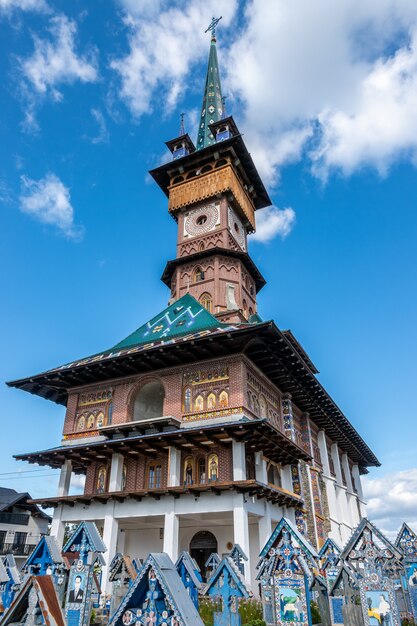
left=20, top=15, right=98, bottom=101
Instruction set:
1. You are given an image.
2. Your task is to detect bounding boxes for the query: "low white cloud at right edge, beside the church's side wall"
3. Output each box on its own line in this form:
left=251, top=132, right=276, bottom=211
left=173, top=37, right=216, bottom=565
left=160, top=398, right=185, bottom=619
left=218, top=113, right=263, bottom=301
left=362, top=468, right=417, bottom=539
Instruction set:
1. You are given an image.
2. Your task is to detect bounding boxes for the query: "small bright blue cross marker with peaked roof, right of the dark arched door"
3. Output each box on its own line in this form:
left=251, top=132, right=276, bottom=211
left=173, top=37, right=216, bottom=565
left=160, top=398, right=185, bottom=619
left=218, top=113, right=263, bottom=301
left=204, top=556, right=249, bottom=626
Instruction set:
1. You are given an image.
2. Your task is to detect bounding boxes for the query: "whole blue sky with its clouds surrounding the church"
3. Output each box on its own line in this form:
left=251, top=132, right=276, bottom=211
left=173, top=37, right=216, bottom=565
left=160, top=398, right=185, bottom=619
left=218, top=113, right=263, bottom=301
left=0, top=0, right=417, bottom=532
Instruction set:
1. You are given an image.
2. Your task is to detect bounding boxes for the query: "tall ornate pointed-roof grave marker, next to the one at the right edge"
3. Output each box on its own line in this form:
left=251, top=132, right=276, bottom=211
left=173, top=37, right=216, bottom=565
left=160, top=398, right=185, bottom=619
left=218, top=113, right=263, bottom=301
left=341, top=518, right=402, bottom=626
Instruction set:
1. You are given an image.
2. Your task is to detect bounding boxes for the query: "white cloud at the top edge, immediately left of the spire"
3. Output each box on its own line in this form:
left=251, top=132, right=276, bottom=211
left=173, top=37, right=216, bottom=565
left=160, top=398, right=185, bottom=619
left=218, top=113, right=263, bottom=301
left=111, top=0, right=237, bottom=118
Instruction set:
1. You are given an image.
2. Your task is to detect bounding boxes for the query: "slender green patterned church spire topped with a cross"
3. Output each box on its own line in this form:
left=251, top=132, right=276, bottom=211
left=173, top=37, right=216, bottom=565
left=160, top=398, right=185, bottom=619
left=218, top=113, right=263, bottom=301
left=197, top=17, right=223, bottom=150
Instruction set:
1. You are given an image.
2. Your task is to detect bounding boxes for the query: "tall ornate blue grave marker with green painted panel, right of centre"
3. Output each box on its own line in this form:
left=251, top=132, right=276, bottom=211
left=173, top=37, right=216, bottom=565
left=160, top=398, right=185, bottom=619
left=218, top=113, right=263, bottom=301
left=257, top=517, right=318, bottom=626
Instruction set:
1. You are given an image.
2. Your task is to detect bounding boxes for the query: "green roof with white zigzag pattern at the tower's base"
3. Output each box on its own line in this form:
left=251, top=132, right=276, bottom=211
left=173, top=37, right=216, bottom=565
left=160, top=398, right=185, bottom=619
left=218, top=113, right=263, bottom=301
left=112, top=293, right=229, bottom=351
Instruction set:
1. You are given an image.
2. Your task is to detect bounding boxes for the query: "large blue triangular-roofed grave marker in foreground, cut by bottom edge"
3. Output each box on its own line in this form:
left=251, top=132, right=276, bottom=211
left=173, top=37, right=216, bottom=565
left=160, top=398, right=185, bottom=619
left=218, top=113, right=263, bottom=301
left=109, top=553, right=204, bottom=626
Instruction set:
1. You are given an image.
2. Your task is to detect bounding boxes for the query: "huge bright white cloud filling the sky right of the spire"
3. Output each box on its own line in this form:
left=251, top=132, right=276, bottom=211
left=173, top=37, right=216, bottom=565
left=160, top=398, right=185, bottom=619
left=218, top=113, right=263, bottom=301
left=227, top=0, right=417, bottom=184
